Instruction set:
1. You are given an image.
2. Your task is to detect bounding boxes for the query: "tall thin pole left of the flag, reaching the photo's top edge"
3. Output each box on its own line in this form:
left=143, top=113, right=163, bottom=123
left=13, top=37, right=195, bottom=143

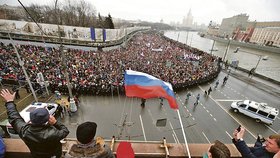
left=55, top=0, right=77, bottom=112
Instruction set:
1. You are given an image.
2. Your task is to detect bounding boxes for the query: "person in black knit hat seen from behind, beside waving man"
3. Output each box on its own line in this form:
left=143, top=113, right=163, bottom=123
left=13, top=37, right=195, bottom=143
left=65, top=122, right=115, bottom=158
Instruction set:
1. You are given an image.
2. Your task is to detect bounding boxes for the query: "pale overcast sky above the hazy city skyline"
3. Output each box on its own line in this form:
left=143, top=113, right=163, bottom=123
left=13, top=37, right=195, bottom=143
left=0, top=0, right=280, bottom=25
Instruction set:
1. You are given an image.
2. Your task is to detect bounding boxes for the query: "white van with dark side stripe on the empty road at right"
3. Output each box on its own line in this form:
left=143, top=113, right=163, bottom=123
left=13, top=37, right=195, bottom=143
left=231, top=100, right=279, bottom=124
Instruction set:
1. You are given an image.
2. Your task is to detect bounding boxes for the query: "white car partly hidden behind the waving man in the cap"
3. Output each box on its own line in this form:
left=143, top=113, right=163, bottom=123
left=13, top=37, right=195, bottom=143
left=6, top=102, right=58, bottom=134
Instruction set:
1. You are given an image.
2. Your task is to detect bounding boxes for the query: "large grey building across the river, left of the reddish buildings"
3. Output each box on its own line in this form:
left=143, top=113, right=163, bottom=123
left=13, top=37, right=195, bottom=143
left=218, top=14, right=249, bottom=38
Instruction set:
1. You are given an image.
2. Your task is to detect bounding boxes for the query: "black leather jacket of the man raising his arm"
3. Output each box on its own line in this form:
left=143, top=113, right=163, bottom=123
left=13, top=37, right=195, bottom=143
left=5, top=102, right=69, bottom=158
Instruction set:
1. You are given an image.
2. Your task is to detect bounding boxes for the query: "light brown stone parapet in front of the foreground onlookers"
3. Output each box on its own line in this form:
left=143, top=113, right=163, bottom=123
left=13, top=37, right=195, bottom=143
left=4, top=138, right=241, bottom=158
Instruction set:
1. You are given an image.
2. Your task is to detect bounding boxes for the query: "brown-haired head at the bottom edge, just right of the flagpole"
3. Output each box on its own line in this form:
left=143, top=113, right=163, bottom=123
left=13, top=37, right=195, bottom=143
left=203, top=140, right=230, bottom=158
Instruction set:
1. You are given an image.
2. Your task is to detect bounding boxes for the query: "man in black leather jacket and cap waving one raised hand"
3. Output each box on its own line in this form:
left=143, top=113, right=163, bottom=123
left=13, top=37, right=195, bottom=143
left=1, top=89, right=69, bottom=158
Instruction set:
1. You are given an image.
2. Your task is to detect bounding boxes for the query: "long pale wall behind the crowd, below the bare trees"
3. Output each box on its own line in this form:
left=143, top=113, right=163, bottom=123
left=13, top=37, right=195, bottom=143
left=0, top=19, right=150, bottom=42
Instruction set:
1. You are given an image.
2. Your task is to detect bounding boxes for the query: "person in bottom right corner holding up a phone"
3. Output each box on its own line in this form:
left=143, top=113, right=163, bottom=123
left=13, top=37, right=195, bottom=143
left=232, top=127, right=280, bottom=158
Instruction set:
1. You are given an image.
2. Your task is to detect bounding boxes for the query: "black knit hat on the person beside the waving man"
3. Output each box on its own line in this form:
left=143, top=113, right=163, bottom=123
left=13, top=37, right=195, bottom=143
left=76, top=121, right=97, bottom=144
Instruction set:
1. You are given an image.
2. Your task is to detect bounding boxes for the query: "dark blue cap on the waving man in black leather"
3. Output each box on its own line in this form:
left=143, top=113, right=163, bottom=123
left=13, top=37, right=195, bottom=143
left=30, top=108, right=50, bottom=125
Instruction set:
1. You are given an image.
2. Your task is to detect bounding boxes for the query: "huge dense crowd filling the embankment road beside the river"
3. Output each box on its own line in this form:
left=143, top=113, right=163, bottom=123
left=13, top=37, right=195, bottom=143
left=0, top=32, right=219, bottom=94
